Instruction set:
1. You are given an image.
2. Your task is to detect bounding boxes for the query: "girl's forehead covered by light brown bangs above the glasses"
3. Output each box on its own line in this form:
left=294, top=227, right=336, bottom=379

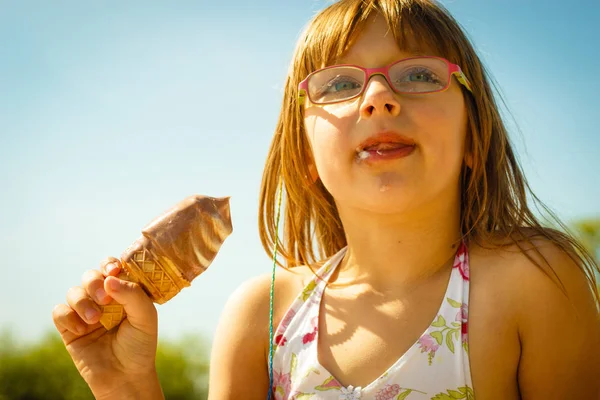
left=297, top=0, right=460, bottom=76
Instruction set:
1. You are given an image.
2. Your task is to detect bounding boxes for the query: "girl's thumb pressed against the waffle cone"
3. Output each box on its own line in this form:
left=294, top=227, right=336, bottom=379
left=104, top=276, right=158, bottom=334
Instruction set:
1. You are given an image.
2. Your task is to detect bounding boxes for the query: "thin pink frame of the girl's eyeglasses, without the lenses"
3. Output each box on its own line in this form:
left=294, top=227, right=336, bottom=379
left=298, top=56, right=473, bottom=105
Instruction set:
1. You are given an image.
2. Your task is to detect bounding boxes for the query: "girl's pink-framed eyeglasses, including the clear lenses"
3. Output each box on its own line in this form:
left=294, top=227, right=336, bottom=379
left=298, top=57, right=472, bottom=104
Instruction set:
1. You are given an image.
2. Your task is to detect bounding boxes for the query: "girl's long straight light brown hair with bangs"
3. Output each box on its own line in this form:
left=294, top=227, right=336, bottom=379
left=259, top=0, right=600, bottom=301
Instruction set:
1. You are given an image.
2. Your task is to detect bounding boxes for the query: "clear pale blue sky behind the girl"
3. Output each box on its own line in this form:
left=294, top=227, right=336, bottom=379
left=0, top=0, right=600, bottom=340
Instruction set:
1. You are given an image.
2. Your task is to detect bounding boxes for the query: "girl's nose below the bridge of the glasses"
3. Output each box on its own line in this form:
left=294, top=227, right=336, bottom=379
left=360, top=76, right=400, bottom=119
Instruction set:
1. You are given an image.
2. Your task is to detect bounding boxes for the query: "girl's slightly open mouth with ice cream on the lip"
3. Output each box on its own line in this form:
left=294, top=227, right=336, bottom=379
left=356, top=131, right=416, bottom=160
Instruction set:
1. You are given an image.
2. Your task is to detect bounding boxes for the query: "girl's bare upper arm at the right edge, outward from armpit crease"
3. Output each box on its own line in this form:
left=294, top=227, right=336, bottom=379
left=516, top=242, right=600, bottom=400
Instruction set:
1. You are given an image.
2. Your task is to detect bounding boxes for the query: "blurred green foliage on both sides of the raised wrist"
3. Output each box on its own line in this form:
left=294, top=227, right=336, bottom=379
left=0, top=331, right=208, bottom=400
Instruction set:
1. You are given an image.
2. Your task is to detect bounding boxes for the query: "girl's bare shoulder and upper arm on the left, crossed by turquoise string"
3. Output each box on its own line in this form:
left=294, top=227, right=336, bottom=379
left=209, top=267, right=310, bottom=399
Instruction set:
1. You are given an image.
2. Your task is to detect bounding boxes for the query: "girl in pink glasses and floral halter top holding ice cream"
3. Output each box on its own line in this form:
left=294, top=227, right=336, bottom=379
left=53, top=0, right=600, bottom=400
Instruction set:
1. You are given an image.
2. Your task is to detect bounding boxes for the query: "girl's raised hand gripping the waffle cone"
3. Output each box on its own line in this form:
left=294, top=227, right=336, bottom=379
left=52, top=257, right=162, bottom=398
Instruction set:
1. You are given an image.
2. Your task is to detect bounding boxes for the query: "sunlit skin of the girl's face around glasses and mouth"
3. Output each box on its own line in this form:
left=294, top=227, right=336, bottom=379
left=304, top=16, right=467, bottom=219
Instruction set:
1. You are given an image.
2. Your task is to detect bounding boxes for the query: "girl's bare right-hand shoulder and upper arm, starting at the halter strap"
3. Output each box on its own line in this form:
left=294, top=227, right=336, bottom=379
left=472, top=232, right=600, bottom=398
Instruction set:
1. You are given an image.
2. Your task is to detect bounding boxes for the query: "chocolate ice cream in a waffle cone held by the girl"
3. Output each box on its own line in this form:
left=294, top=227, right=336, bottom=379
left=100, top=196, right=233, bottom=329
